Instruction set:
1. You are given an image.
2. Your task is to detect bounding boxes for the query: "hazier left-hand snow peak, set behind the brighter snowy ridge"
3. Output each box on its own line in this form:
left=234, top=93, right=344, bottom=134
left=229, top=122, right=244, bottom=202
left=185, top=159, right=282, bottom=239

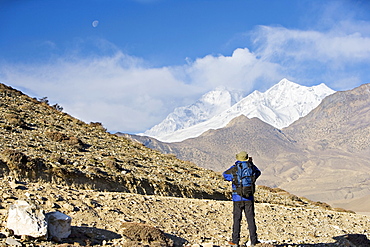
left=143, top=87, right=243, bottom=138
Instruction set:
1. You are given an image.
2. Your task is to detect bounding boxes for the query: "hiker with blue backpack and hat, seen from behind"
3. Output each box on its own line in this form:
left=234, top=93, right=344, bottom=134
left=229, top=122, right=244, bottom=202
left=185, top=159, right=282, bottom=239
left=222, top=151, right=261, bottom=246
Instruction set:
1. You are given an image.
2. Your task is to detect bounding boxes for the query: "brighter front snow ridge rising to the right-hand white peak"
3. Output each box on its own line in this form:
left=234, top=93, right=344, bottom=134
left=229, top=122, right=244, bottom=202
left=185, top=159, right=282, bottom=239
left=144, top=79, right=334, bottom=142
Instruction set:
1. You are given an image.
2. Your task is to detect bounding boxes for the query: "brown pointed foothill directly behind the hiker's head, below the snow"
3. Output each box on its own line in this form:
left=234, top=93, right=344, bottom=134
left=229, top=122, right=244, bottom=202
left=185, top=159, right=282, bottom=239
left=125, top=115, right=299, bottom=171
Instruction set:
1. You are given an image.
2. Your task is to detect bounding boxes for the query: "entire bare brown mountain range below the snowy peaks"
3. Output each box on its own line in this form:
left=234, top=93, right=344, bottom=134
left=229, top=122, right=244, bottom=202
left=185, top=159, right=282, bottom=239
left=125, top=84, right=370, bottom=211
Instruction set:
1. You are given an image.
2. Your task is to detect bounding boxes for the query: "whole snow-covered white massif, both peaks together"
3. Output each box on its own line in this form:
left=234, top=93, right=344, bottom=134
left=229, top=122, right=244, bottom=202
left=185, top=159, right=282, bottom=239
left=144, top=79, right=335, bottom=142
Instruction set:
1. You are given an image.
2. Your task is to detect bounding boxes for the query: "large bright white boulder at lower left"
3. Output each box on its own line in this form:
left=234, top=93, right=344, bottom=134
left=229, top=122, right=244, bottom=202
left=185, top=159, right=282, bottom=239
left=6, top=200, right=47, bottom=238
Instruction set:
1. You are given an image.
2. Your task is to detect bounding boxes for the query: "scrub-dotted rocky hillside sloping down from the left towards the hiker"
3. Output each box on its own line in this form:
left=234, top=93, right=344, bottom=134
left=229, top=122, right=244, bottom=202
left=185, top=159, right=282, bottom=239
left=0, top=84, right=227, bottom=199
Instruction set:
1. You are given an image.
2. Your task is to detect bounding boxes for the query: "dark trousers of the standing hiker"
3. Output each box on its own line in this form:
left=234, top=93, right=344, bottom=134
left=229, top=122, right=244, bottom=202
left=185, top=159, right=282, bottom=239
left=232, top=201, right=257, bottom=245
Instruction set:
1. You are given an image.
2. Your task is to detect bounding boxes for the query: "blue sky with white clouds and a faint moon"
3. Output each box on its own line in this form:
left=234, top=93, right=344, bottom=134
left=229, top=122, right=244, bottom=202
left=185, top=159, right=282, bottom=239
left=0, top=0, right=370, bottom=133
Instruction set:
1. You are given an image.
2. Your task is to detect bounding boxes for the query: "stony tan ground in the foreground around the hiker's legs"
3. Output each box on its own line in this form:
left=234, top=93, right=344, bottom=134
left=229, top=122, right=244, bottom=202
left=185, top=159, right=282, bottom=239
left=0, top=178, right=370, bottom=247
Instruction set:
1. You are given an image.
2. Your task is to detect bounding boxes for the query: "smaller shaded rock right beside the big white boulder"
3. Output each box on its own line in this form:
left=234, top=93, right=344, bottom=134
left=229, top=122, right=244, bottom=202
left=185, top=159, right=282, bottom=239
left=46, top=211, right=72, bottom=239
